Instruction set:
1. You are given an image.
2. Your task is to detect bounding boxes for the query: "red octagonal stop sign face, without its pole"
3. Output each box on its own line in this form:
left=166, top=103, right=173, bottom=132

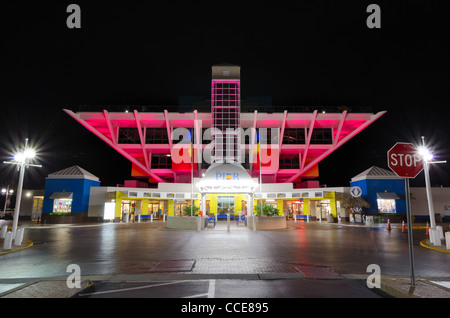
left=388, top=142, right=423, bottom=178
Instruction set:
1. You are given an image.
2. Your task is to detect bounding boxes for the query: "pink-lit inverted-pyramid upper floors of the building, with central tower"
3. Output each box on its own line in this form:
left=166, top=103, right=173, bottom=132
left=64, top=65, right=385, bottom=187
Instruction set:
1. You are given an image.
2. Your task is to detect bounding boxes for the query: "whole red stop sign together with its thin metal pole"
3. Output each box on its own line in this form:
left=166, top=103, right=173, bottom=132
left=387, top=142, right=423, bottom=286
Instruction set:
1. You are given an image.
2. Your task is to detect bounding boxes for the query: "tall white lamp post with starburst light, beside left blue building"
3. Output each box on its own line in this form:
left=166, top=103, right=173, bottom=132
left=3, top=138, right=42, bottom=238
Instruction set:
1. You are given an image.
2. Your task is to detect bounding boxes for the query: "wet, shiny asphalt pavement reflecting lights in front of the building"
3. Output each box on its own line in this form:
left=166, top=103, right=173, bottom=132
left=0, top=221, right=450, bottom=298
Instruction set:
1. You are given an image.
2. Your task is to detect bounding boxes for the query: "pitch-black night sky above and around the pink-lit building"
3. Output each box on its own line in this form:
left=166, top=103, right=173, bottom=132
left=0, top=0, right=450, bottom=188
